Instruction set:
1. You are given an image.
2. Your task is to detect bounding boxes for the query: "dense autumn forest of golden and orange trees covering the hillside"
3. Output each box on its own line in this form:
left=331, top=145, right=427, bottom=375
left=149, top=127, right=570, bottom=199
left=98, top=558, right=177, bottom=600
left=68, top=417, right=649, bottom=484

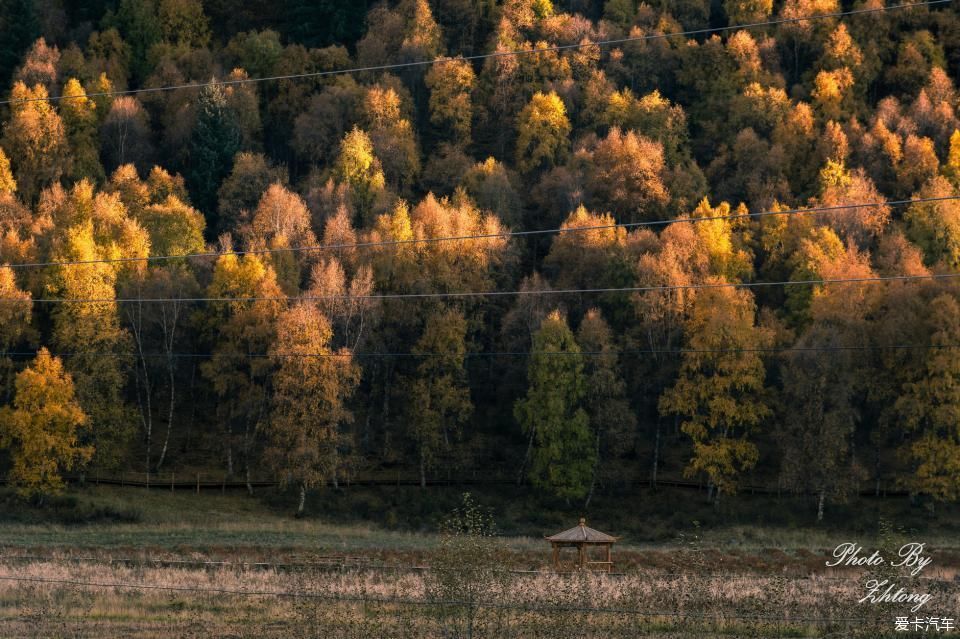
left=0, top=0, right=960, bottom=518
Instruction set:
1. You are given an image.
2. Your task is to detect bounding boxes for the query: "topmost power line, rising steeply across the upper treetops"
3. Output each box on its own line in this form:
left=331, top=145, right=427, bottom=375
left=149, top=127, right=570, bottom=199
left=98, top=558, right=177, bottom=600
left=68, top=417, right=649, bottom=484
left=0, top=0, right=952, bottom=105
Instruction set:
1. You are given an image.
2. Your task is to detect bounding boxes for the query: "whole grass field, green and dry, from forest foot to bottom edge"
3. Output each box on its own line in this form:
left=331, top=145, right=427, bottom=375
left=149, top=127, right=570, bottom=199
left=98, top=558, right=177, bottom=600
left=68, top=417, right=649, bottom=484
left=0, top=487, right=960, bottom=638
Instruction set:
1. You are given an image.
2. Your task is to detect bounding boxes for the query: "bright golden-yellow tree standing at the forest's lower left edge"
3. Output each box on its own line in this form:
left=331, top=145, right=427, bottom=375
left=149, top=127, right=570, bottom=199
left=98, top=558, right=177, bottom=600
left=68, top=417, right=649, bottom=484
left=0, top=348, right=93, bottom=500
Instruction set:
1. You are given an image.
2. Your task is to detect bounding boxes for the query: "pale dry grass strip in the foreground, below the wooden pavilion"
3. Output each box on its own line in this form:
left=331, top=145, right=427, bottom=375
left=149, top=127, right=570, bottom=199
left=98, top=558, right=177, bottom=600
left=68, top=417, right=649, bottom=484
left=0, top=557, right=960, bottom=638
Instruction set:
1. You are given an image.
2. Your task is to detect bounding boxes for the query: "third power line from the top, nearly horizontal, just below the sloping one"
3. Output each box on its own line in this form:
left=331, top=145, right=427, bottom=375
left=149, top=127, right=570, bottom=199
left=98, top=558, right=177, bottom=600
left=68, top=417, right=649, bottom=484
left=7, top=273, right=960, bottom=304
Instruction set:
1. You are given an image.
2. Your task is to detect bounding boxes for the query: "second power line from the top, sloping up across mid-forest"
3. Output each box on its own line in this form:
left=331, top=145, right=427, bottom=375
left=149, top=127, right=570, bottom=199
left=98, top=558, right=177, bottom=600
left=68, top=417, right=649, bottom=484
left=0, top=195, right=960, bottom=269
